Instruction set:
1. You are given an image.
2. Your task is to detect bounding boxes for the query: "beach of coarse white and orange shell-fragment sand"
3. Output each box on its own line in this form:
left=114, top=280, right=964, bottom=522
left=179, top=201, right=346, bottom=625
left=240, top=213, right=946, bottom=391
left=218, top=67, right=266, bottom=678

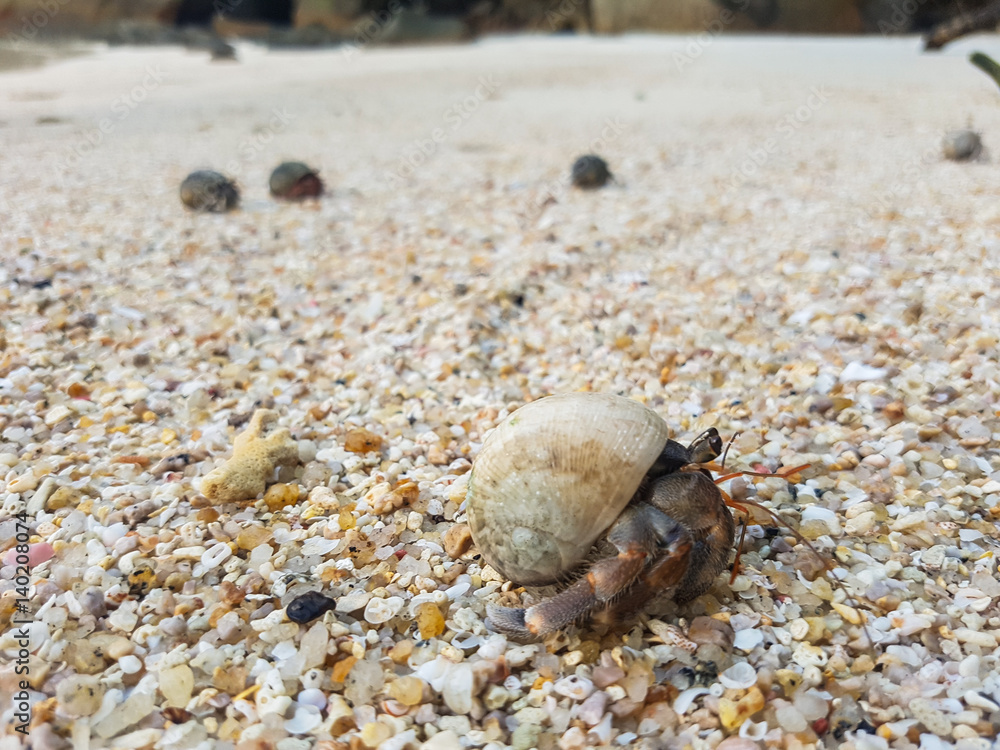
left=0, top=35, right=1000, bottom=750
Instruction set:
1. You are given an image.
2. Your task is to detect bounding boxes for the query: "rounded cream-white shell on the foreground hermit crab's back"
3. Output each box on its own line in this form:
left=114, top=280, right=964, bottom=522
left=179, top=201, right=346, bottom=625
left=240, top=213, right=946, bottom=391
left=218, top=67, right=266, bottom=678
left=467, top=393, right=669, bottom=585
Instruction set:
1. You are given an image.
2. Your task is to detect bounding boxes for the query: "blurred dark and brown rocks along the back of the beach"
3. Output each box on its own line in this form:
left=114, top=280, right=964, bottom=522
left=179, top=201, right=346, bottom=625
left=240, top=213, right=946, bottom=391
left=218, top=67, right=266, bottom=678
left=0, top=0, right=997, bottom=46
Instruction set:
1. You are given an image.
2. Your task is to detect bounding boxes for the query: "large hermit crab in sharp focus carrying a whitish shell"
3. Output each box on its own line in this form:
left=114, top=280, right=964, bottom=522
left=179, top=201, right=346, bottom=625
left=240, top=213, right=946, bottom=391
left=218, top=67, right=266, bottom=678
left=467, top=393, right=804, bottom=637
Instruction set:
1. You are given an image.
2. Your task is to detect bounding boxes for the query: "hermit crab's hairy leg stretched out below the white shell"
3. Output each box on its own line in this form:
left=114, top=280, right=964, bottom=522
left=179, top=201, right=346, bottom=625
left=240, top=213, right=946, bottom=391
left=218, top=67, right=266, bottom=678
left=490, top=503, right=683, bottom=636
